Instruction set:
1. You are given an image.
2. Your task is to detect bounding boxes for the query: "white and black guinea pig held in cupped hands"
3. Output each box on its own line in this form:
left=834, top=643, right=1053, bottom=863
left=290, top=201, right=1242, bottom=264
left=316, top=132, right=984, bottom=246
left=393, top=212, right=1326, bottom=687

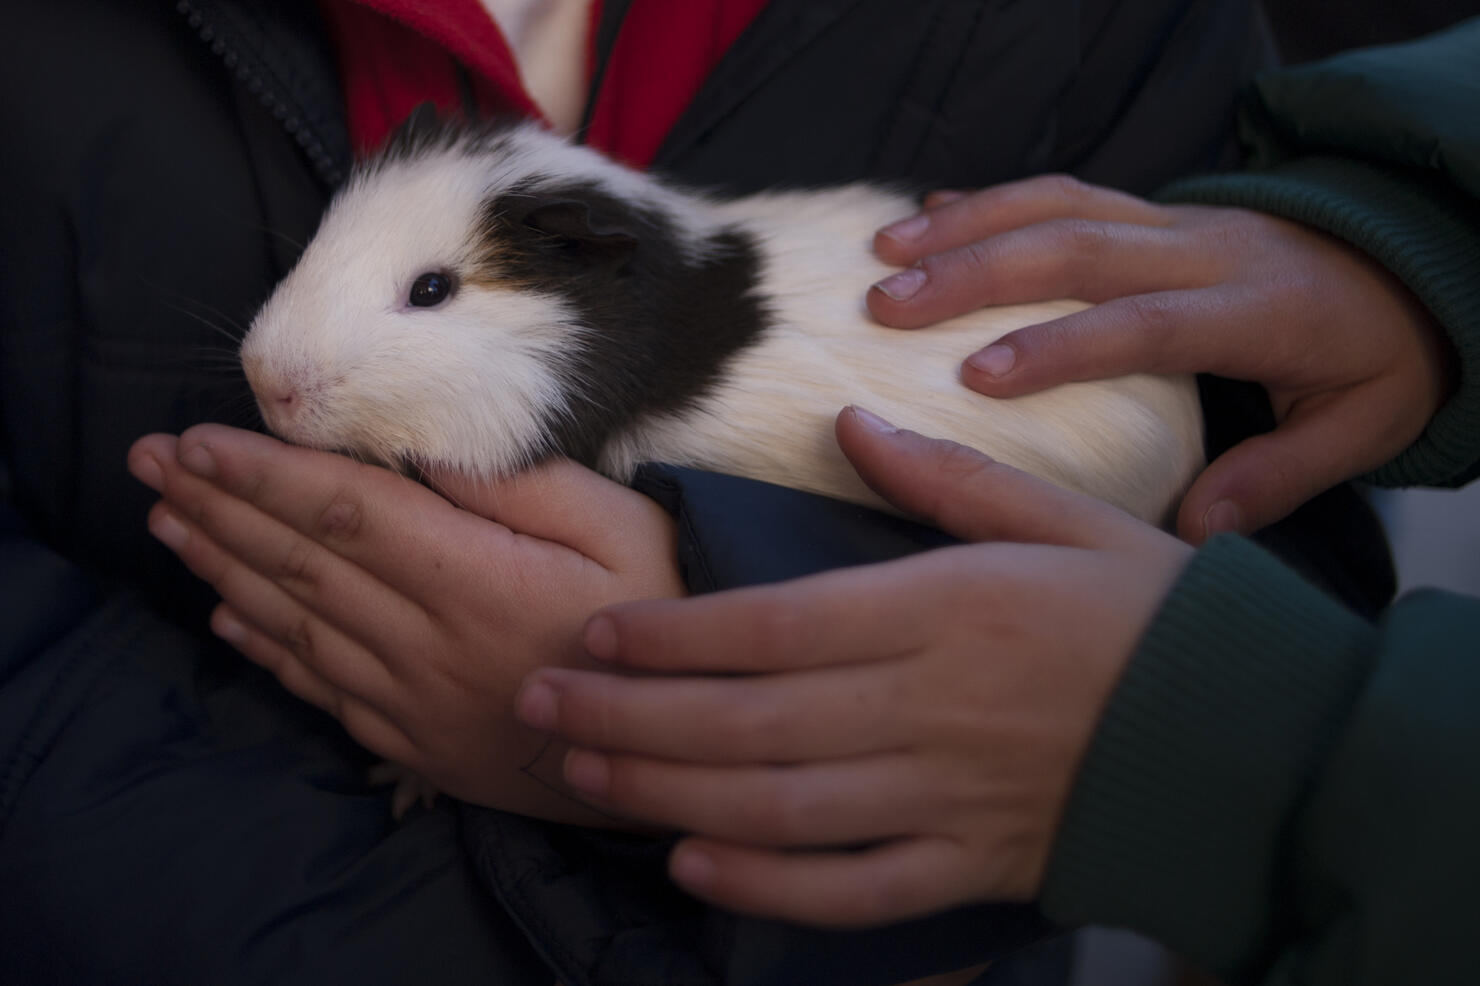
left=241, top=113, right=1203, bottom=523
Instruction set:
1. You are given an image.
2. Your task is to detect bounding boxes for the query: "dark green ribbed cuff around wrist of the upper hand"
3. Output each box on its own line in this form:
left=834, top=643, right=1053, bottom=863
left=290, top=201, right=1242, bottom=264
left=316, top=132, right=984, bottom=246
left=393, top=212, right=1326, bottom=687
left=1157, top=157, right=1480, bottom=486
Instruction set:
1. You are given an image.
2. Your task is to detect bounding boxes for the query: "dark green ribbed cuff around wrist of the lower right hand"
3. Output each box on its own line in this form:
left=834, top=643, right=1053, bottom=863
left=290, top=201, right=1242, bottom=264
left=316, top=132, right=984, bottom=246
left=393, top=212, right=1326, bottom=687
left=1042, top=536, right=1376, bottom=979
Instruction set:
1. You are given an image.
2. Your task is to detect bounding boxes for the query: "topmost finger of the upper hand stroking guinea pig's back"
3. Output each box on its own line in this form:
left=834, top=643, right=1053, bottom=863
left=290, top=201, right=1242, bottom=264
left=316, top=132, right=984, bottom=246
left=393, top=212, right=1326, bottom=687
left=873, top=175, right=1172, bottom=266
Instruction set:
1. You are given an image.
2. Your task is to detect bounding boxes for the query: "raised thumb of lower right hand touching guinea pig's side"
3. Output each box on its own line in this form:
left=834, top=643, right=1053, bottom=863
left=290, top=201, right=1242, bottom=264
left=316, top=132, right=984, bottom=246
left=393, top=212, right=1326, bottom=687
left=836, top=407, right=1143, bottom=548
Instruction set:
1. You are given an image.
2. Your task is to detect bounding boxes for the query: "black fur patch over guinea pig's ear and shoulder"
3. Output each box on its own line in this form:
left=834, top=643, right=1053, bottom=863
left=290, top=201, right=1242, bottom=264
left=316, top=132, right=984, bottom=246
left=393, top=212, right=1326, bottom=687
left=475, top=178, right=768, bottom=465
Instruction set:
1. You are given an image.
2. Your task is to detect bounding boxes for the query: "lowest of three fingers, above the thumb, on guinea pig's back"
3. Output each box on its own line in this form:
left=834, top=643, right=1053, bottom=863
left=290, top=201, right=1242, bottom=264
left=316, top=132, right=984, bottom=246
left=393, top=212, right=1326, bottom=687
left=961, top=287, right=1283, bottom=397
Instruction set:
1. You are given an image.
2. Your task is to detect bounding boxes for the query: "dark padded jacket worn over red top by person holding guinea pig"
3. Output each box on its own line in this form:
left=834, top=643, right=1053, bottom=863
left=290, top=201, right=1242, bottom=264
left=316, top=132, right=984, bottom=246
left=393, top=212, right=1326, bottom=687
left=0, top=0, right=1385, bottom=986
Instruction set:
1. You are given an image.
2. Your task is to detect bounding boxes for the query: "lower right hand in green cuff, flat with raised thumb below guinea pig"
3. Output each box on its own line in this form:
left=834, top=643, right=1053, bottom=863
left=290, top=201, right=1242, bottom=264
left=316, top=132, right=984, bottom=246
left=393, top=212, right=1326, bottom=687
left=517, top=410, right=1191, bottom=925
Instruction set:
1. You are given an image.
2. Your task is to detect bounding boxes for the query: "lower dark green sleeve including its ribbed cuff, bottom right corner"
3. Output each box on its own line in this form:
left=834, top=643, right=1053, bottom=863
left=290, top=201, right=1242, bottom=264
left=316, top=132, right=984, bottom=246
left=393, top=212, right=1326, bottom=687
left=1043, top=536, right=1480, bottom=986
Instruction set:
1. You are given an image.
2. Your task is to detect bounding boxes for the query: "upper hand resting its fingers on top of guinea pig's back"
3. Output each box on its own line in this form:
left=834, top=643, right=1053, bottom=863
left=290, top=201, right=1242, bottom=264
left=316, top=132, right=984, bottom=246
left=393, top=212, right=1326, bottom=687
left=869, top=176, right=1452, bottom=542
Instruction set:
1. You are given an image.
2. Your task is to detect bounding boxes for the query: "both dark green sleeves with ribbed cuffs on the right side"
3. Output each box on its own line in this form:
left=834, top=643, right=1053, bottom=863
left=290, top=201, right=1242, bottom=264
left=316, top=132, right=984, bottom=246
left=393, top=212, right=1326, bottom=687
left=1043, top=19, right=1480, bottom=986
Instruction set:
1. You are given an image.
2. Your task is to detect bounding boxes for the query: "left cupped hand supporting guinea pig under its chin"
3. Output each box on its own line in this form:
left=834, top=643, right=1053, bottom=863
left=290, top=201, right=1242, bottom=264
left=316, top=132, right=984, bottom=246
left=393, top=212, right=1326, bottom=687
left=129, top=425, right=684, bottom=823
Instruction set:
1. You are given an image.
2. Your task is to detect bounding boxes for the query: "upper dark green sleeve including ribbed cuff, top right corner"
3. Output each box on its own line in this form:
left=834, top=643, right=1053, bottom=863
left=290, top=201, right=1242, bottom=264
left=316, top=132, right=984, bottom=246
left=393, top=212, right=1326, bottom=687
left=1157, top=18, right=1480, bottom=486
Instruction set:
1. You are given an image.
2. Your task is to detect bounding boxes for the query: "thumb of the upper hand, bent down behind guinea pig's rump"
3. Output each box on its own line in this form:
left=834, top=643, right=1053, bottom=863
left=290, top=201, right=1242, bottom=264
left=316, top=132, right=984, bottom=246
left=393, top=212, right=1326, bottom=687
left=1177, top=388, right=1402, bottom=543
